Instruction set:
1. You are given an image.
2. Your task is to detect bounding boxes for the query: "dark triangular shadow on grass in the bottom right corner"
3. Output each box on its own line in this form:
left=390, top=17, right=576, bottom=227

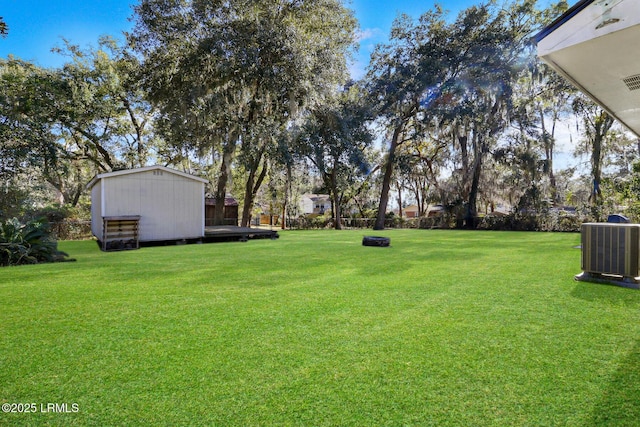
left=590, top=341, right=640, bottom=426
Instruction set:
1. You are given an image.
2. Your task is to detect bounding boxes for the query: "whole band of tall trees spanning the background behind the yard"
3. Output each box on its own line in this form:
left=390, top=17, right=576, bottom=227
left=0, top=0, right=640, bottom=229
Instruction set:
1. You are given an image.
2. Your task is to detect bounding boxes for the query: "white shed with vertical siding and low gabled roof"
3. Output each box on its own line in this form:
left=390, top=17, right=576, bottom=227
left=87, top=166, right=207, bottom=249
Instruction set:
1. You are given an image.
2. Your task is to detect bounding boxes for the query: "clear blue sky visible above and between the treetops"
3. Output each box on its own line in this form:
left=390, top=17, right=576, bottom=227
left=0, top=0, right=516, bottom=78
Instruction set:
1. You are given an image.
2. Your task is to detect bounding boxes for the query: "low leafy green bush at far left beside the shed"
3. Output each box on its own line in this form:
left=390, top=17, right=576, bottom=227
left=0, top=218, right=68, bottom=266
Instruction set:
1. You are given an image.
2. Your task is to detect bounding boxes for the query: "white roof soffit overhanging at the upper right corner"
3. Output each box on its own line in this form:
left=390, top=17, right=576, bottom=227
left=538, top=0, right=640, bottom=136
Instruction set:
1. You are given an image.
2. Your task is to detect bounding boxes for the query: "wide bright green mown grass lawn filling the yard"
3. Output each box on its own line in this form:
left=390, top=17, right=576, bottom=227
left=0, top=230, right=640, bottom=426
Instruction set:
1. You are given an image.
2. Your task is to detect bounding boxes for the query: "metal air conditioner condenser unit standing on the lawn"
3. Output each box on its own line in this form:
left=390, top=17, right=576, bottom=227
left=575, top=223, right=640, bottom=289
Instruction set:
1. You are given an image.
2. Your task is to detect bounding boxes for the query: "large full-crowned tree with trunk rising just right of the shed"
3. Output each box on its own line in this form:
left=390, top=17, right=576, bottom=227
left=129, top=0, right=356, bottom=223
